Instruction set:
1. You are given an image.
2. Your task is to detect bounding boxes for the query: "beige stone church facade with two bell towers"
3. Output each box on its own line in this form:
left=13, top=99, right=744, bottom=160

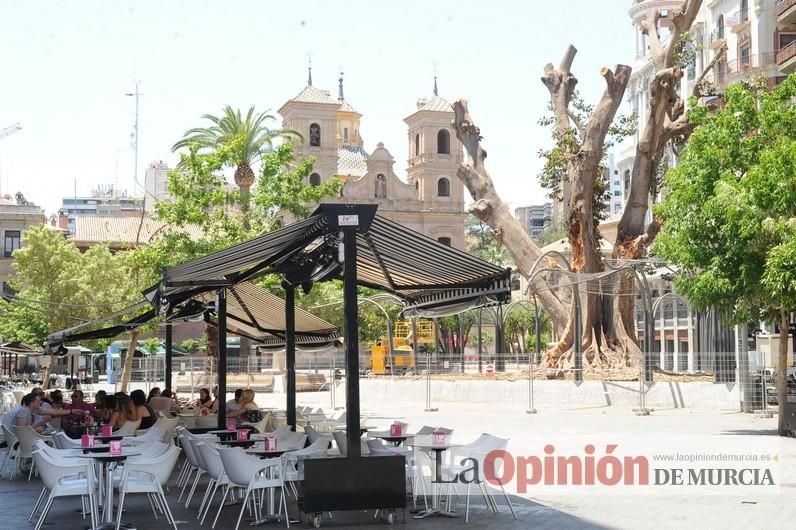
left=279, top=76, right=467, bottom=250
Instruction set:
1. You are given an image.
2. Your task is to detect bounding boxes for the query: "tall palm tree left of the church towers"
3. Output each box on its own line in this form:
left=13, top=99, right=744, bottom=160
left=171, top=105, right=303, bottom=225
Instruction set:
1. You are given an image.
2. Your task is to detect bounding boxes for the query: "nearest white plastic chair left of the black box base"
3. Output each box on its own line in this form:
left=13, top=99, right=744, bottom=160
left=218, top=447, right=290, bottom=530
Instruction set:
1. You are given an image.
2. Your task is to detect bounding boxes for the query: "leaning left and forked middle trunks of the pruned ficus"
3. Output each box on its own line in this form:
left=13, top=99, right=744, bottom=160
left=453, top=46, right=631, bottom=366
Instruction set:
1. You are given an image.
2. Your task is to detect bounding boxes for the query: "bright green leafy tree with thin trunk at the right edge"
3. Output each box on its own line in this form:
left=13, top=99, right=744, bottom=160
left=654, top=75, right=796, bottom=434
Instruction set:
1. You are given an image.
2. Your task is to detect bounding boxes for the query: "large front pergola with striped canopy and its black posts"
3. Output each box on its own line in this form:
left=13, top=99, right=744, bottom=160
left=155, top=204, right=511, bottom=457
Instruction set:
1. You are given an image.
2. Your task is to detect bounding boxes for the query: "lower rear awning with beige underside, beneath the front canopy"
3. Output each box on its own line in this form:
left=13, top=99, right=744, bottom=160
left=47, top=282, right=339, bottom=352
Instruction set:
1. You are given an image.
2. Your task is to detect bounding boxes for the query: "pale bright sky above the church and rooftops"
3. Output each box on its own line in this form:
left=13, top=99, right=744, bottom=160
left=0, top=0, right=633, bottom=213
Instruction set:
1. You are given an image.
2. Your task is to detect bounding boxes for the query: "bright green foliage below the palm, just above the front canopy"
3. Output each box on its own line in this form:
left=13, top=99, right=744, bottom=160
left=129, top=141, right=340, bottom=288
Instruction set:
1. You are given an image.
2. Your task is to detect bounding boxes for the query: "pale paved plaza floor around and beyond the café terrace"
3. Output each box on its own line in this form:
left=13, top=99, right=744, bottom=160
left=0, top=393, right=796, bottom=530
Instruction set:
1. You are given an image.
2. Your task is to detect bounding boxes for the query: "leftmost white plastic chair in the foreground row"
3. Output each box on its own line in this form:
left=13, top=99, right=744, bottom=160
left=33, top=451, right=99, bottom=530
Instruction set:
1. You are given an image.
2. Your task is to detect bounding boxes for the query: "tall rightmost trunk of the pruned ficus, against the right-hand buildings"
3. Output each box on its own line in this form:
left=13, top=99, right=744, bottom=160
left=613, top=0, right=726, bottom=348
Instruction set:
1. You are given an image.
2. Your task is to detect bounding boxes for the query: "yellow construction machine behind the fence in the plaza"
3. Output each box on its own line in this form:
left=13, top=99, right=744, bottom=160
left=370, top=320, right=434, bottom=375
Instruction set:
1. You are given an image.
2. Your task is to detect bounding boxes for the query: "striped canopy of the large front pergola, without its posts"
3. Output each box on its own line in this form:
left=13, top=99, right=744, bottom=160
left=160, top=204, right=511, bottom=309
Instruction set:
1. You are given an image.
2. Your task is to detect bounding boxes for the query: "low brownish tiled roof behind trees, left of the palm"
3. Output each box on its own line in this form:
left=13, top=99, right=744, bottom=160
left=70, top=215, right=202, bottom=247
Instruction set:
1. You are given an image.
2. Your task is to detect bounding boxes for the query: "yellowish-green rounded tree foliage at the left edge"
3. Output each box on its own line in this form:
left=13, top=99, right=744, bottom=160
left=0, top=226, right=141, bottom=345
